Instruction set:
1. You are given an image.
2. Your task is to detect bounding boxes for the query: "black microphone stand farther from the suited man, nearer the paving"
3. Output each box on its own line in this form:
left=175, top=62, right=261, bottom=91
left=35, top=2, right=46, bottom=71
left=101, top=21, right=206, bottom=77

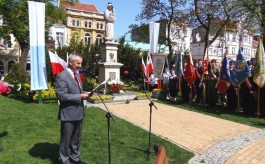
left=128, top=72, right=157, bottom=160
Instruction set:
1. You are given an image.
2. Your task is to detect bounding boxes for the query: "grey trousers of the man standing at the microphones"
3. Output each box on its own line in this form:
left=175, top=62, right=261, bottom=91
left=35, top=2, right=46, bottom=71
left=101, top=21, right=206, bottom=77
left=59, top=120, right=83, bottom=164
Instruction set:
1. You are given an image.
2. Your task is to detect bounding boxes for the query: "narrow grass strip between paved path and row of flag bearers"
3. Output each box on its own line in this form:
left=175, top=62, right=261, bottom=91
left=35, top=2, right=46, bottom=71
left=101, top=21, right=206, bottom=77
left=158, top=97, right=265, bottom=128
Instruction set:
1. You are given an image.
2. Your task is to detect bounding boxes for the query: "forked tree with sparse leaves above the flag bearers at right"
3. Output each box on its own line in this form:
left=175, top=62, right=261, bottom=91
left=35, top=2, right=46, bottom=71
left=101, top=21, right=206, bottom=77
left=192, top=0, right=260, bottom=55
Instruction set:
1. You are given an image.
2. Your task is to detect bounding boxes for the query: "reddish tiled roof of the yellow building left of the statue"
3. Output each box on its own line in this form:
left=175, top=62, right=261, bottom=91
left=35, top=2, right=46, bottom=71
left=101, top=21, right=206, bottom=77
left=61, top=3, right=99, bottom=13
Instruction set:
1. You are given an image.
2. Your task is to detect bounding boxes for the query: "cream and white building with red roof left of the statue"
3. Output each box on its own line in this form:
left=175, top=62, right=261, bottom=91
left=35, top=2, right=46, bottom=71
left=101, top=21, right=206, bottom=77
left=50, top=3, right=105, bottom=48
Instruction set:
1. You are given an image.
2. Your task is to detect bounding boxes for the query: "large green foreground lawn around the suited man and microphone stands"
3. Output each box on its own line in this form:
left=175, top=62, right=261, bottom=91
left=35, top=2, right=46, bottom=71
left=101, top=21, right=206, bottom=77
left=0, top=96, right=193, bottom=164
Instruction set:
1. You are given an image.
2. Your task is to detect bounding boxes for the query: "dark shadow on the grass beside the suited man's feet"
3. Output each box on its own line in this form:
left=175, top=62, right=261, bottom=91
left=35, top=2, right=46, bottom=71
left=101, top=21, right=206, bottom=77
left=29, top=142, right=60, bottom=164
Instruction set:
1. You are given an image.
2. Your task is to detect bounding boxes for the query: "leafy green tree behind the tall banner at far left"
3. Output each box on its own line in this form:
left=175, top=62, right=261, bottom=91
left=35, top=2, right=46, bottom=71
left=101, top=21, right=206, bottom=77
left=0, top=0, right=66, bottom=69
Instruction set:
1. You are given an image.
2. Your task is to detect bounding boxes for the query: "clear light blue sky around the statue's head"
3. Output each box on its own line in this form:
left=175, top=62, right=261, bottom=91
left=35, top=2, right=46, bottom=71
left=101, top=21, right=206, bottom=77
left=79, top=0, right=141, bottom=40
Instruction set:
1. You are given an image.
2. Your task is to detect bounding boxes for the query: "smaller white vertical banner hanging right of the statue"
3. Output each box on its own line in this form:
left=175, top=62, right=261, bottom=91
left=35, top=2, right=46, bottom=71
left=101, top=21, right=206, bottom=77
left=149, top=22, right=160, bottom=54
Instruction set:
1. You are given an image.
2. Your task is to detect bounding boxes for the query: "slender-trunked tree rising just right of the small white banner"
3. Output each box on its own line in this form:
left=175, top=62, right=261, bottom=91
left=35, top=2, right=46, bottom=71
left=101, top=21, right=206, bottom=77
left=136, top=0, right=188, bottom=58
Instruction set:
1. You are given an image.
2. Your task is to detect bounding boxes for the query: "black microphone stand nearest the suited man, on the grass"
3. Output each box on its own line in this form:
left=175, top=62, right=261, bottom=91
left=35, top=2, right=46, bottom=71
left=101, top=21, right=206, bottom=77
left=85, top=77, right=115, bottom=164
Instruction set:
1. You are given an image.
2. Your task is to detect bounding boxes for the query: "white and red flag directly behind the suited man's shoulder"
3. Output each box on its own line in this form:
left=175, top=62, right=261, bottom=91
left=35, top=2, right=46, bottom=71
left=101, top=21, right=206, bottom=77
left=49, top=51, right=67, bottom=75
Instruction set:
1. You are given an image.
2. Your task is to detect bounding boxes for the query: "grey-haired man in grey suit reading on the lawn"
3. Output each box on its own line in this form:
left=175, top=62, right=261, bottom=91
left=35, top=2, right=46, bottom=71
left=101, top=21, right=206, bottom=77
left=55, top=53, right=89, bottom=164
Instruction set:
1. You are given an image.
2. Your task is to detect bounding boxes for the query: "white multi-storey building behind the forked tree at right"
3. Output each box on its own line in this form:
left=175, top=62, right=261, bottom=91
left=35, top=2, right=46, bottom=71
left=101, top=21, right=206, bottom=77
left=191, top=24, right=252, bottom=62
